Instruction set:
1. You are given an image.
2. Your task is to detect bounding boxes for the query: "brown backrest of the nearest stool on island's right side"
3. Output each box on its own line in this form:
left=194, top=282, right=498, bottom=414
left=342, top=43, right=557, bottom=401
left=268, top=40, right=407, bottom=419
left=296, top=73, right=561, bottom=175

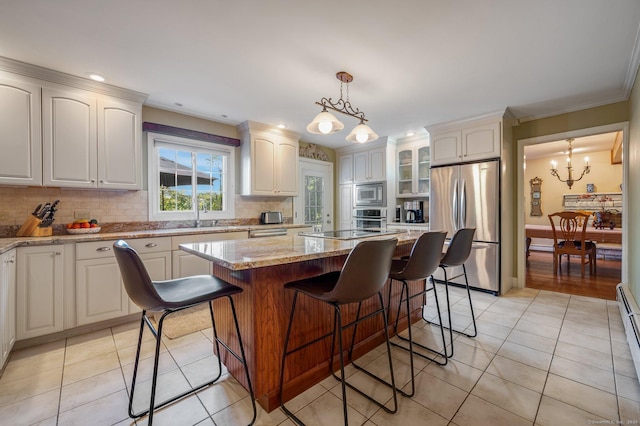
left=330, top=238, right=398, bottom=304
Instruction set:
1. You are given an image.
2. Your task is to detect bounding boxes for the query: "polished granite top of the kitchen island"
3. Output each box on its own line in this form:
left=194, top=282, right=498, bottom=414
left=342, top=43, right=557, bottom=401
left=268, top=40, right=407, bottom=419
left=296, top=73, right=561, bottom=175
left=180, top=230, right=423, bottom=270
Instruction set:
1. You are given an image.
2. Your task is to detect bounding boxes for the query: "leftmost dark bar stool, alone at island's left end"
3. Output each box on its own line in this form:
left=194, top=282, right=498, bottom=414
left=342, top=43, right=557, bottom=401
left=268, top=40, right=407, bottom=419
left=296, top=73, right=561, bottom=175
left=113, top=240, right=256, bottom=425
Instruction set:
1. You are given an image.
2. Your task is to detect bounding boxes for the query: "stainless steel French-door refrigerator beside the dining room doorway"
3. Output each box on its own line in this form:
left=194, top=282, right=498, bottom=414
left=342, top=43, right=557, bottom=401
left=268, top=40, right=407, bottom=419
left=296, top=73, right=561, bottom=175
left=429, top=160, right=500, bottom=295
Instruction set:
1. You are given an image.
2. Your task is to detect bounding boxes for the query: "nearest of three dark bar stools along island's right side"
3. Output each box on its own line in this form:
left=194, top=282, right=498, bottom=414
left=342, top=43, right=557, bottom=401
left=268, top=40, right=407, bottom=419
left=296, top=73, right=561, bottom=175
left=280, top=238, right=398, bottom=425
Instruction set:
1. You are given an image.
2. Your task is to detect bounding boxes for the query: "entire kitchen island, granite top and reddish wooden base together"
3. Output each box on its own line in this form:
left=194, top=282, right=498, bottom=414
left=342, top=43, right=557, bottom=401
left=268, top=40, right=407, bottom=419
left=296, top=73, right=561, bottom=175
left=180, top=231, right=423, bottom=411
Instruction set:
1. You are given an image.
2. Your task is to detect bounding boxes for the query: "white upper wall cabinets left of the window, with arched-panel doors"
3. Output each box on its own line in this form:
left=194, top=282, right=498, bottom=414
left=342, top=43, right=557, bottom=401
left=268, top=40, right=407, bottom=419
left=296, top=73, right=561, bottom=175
left=0, top=58, right=146, bottom=189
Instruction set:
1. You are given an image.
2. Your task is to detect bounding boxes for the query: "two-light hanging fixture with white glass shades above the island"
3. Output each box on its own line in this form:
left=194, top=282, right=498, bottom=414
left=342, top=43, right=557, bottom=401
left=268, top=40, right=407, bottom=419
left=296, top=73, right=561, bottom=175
left=307, top=71, right=378, bottom=143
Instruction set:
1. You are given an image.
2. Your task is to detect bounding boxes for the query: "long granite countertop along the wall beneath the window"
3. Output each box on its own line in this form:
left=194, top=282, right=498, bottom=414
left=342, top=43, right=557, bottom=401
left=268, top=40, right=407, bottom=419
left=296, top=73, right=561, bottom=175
left=0, top=223, right=308, bottom=254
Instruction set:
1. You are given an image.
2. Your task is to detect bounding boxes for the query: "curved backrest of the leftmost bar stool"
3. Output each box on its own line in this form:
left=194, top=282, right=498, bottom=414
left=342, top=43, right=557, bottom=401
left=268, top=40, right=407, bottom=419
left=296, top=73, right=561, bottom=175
left=113, top=240, right=163, bottom=310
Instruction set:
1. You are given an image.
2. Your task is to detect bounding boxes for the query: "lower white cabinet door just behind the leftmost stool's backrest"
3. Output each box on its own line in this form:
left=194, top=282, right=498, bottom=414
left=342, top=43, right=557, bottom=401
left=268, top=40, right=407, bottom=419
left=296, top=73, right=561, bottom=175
left=76, top=257, right=129, bottom=325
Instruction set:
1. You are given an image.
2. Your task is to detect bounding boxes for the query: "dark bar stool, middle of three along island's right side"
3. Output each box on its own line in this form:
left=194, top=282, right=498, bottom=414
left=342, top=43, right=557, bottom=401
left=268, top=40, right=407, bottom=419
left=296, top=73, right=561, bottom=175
left=387, top=232, right=448, bottom=397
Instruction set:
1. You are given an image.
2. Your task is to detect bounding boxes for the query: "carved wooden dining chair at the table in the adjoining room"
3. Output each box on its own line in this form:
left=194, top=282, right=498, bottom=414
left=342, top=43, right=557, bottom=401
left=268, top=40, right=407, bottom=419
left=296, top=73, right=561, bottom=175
left=548, top=211, right=596, bottom=277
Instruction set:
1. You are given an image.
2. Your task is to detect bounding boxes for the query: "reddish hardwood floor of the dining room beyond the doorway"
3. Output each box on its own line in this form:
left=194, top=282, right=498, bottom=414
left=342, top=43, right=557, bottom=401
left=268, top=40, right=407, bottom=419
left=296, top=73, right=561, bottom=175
left=526, top=251, right=622, bottom=300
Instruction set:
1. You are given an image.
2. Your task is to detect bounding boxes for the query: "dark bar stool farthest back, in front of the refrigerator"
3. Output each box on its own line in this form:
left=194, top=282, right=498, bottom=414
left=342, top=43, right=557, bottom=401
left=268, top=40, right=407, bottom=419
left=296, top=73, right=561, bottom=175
left=434, top=228, right=478, bottom=357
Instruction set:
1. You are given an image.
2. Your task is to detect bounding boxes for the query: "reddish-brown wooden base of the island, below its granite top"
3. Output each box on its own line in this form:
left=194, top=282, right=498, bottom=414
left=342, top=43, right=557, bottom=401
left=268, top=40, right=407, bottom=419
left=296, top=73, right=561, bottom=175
left=205, top=241, right=424, bottom=412
